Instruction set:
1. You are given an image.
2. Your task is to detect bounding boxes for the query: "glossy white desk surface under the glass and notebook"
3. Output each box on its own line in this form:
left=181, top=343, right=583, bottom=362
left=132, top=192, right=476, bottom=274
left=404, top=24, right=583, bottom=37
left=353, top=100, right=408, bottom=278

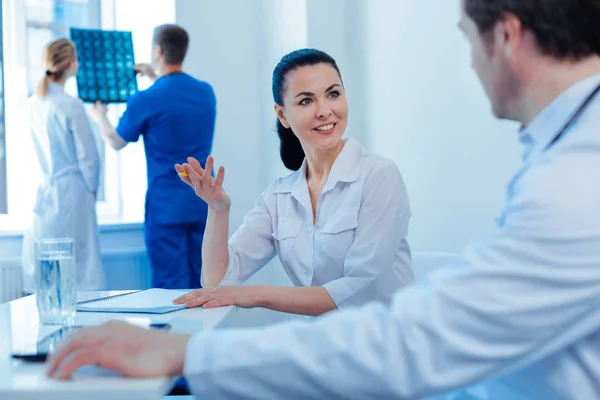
left=0, top=291, right=236, bottom=400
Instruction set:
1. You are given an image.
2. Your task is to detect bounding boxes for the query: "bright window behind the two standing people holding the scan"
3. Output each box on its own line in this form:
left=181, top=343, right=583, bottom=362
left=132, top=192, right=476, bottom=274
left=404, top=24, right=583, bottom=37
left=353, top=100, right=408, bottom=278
left=0, top=0, right=175, bottom=231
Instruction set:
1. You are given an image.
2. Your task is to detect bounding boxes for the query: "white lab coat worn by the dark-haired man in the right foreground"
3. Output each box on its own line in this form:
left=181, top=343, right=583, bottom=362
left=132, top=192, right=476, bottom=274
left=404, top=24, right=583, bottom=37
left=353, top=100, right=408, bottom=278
left=185, top=74, right=600, bottom=400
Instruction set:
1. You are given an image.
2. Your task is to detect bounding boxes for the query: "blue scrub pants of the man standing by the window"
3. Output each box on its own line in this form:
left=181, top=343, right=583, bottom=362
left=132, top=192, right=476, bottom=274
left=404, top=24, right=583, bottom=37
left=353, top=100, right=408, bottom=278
left=144, top=221, right=206, bottom=289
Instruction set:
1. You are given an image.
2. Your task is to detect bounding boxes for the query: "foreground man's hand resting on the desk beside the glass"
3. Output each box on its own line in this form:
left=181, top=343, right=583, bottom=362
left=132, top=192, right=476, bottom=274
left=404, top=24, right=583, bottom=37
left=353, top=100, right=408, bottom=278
left=47, top=321, right=190, bottom=379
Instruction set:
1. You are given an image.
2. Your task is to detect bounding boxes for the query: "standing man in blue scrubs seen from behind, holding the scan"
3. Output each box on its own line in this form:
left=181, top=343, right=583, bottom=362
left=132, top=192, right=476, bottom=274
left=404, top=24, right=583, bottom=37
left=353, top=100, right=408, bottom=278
left=93, top=25, right=216, bottom=289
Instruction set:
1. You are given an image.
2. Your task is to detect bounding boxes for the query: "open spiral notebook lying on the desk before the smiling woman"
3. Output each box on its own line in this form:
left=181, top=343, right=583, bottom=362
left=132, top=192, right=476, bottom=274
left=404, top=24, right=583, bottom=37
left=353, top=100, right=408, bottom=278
left=77, top=289, right=187, bottom=314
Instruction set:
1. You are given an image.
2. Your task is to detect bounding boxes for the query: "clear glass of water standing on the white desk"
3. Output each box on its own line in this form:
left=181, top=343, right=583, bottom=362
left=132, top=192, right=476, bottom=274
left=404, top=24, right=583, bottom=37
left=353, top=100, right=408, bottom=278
left=35, top=238, right=77, bottom=325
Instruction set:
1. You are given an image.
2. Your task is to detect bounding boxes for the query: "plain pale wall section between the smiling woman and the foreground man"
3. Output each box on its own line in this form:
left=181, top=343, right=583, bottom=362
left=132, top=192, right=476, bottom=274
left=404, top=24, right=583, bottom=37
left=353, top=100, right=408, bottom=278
left=364, top=0, right=520, bottom=252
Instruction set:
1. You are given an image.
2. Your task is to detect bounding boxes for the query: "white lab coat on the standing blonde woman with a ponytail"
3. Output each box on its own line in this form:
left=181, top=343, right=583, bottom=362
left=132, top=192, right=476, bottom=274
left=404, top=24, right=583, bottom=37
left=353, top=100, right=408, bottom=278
left=22, top=83, right=104, bottom=293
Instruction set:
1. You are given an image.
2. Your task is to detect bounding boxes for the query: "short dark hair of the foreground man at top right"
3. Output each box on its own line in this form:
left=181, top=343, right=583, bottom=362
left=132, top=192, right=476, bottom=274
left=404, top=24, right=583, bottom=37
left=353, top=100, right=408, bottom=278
left=465, top=0, right=600, bottom=60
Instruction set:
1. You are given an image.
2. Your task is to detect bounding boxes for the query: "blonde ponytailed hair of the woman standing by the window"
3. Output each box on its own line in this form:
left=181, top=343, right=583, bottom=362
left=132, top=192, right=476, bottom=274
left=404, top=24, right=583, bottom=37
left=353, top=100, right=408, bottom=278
left=36, top=38, right=76, bottom=97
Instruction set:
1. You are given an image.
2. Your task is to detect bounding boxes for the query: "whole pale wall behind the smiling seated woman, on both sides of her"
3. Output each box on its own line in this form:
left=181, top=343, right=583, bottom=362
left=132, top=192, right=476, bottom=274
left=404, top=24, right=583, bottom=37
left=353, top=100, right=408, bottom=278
left=176, top=0, right=520, bottom=252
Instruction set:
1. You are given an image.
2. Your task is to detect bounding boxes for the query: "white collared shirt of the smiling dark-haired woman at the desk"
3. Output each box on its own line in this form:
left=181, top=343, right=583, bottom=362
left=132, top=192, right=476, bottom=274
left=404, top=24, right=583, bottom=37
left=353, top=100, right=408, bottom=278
left=210, top=138, right=414, bottom=307
